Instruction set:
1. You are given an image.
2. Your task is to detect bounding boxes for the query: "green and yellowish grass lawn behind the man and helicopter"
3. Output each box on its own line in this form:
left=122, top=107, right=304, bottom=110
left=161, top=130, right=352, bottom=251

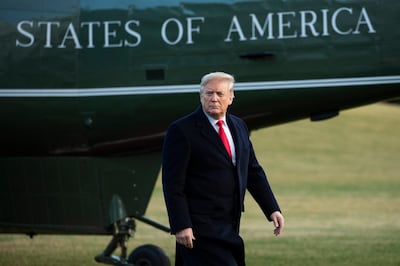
left=0, top=104, right=400, bottom=266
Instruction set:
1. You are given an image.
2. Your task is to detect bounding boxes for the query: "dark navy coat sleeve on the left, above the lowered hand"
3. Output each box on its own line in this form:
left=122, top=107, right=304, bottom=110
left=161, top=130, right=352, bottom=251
left=162, top=121, right=192, bottom=234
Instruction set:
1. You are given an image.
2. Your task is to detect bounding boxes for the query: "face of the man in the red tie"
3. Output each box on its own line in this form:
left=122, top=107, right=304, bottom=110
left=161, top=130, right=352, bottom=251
left=200, top=80, right=234, bottom=120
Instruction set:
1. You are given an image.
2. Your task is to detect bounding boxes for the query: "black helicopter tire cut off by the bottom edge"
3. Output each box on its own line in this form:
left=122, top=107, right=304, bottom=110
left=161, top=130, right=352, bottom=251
left=128, top=244, right=171, bottom=266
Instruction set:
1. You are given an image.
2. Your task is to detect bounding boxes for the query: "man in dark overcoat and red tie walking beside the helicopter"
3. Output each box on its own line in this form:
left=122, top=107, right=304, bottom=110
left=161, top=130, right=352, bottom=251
left=162, top=72, right=284, bottom=266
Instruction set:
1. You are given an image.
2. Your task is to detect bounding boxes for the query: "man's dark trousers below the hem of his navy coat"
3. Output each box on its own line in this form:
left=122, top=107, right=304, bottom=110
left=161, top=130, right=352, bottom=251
left=175, top=235, right=246, bottom=266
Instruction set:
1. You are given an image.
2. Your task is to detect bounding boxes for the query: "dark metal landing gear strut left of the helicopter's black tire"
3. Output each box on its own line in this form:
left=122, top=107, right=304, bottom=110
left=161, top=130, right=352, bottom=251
left=95, top=217, right=136, bottom=266
